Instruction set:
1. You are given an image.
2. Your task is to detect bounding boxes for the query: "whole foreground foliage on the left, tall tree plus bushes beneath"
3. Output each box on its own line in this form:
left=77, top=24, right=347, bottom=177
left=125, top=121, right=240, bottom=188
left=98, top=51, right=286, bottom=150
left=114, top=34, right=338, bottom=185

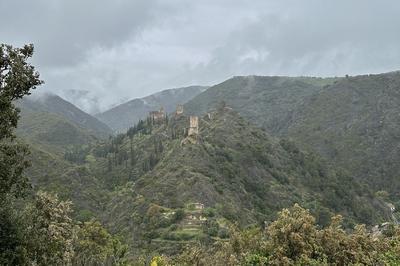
left=0, top=44, right=126, bottom=265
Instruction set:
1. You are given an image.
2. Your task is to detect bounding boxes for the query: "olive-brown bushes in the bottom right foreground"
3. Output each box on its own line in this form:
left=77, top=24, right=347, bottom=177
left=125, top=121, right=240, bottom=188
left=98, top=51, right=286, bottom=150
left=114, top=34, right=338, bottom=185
left=151, top=204, right=400, bottom=266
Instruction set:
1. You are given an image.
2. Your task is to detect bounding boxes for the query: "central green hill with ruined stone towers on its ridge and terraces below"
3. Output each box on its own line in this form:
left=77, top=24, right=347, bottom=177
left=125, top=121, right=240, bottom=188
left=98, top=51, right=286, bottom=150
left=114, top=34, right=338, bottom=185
left=65, top=107, right=388, bottom=254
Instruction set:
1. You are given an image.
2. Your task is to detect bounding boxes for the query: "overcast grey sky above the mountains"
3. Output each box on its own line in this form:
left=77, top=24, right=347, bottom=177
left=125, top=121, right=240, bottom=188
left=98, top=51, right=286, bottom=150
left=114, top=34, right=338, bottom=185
left=0, top=0, right=400, bottom=113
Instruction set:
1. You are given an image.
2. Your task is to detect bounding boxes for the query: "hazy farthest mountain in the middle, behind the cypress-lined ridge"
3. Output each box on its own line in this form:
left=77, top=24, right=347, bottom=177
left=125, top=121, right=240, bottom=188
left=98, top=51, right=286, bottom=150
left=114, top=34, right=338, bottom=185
left=95, top=86, right=207, bottom=132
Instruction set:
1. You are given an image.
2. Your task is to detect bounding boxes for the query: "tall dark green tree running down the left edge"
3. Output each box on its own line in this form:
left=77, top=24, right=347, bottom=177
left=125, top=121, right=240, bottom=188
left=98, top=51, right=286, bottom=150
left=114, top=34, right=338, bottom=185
left=0, top=44, right=42, bottom=265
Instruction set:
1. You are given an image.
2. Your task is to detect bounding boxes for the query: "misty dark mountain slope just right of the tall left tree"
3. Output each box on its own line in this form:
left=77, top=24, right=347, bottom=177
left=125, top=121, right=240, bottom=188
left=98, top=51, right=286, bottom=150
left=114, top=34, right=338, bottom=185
left=17, top=94, right=112, bottom=138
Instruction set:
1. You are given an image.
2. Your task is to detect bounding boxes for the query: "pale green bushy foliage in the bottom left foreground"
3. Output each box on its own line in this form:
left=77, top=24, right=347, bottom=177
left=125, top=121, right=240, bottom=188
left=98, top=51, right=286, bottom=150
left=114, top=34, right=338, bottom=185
left=0, top=191, right=127, bottom=265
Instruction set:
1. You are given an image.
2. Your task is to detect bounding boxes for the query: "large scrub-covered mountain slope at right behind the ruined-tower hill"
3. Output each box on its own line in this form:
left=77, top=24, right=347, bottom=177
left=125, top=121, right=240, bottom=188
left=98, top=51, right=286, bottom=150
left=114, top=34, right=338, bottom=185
left=185, top=72, right=400, bottom=198
